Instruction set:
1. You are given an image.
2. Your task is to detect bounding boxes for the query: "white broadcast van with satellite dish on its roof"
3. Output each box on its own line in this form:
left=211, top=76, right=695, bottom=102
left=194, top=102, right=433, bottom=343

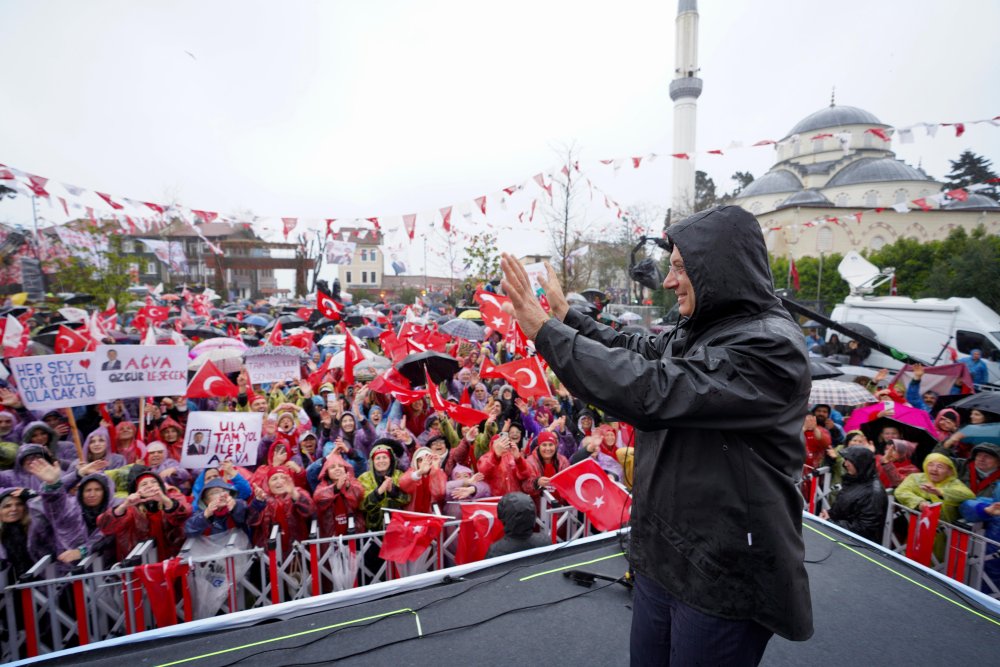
left=830, top=252, right=1000, bottom=384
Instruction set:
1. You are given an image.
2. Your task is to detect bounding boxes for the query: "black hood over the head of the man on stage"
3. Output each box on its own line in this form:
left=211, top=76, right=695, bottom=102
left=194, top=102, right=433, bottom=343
left=667, top=206, right=790, bottom=330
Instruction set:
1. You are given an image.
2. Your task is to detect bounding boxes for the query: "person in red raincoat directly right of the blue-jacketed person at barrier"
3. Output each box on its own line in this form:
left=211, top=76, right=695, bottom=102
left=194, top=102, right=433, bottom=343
left=247, top=466, right=314, bottom=554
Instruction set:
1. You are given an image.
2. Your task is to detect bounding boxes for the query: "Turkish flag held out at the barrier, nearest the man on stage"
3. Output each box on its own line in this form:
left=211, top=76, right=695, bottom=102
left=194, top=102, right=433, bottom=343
left=549, top=457, right=632, bottom=530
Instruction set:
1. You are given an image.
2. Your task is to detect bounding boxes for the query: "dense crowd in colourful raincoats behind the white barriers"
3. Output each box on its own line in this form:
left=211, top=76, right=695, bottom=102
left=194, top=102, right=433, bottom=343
left=0, top=290, right=1000, bottom=624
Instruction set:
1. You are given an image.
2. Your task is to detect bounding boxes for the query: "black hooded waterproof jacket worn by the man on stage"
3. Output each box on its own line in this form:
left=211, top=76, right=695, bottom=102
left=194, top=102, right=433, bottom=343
left=535, top=206, right=813, bottom=640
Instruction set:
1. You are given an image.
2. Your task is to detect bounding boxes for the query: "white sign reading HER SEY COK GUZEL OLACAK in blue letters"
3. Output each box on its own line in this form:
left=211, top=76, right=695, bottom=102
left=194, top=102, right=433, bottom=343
left=10, top=352, right=99, bottom=411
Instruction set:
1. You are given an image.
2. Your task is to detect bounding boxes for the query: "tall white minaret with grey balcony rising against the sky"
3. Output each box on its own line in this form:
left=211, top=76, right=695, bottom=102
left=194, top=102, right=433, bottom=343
left=670, top=0, right=701, bottom=217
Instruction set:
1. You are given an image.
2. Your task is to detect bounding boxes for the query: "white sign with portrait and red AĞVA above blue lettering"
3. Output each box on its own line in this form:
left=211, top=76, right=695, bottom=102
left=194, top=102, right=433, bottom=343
left=93, top=345, right=189, bottom=402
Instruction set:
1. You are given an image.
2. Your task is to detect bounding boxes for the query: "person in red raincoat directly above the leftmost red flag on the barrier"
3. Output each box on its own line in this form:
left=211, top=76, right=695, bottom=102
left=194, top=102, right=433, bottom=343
left=97, top=465, right=191, bottom=561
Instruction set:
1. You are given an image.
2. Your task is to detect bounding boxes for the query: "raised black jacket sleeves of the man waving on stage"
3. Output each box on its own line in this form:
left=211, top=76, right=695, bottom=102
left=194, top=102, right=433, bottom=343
left=535, top=309, right=808, bottom=431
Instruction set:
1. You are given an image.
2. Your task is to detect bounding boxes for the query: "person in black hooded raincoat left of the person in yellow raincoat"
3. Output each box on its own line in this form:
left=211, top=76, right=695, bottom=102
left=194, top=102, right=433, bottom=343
left=820, top=447, right=889, bottom=543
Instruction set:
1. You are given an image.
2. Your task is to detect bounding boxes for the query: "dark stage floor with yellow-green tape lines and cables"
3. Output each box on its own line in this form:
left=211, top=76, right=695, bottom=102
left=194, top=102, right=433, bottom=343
left=31, top=521, right=1000, bottom=667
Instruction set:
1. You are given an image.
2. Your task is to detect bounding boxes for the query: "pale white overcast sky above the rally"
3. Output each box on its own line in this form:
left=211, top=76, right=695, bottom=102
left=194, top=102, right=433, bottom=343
left=0, top=0, right=1000, bottom=284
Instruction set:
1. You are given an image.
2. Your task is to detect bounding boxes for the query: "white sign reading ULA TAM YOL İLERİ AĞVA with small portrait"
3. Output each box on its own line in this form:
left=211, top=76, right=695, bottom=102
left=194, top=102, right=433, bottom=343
left=181, top=411, right=264, bottom=470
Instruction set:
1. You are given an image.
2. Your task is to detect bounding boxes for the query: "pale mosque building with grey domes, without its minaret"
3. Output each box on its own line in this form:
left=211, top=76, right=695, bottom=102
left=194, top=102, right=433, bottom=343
left=733, top=104, right=1000, bottom=258
